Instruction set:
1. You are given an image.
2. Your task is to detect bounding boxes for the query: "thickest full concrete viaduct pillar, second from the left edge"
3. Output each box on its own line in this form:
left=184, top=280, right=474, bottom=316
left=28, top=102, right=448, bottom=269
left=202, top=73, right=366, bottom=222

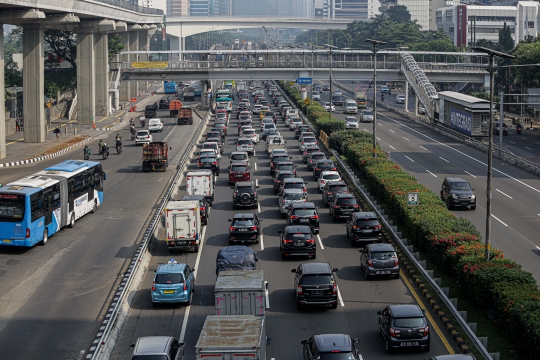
left=23, top=24, right=45, bottom=143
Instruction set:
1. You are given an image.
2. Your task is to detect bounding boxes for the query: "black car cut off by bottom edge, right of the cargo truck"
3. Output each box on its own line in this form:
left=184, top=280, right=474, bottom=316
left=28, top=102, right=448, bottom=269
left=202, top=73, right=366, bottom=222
left=301, top=334, right=362, bottom=360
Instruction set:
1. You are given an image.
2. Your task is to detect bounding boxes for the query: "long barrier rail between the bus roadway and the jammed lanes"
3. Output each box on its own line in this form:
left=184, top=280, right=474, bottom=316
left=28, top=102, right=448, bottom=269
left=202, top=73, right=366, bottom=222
left=86, top=110, right=211, bottom=360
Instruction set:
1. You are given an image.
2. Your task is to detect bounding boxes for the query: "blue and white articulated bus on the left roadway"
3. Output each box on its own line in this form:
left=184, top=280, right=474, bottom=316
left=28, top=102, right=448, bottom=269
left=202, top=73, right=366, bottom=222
left=0, top=160, right=105, bottom=247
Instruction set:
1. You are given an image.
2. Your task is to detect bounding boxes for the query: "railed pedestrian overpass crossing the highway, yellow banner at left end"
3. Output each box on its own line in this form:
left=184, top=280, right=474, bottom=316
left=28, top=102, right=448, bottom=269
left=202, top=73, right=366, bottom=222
left=115, top=49, right=489, bottom=84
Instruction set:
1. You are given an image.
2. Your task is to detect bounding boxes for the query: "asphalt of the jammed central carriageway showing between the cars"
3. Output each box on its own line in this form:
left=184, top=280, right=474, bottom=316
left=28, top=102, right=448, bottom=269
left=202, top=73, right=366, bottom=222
left=112, top=80, right=455, bottom=360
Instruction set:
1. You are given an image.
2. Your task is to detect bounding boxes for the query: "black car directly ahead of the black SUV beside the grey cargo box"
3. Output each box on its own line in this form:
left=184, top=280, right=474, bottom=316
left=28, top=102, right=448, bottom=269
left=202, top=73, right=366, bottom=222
left=279, top=225, right=317, bottom=260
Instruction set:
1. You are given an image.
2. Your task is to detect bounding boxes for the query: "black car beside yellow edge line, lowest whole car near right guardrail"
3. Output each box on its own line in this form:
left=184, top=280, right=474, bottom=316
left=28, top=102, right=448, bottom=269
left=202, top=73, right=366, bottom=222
left=377, top=304, right=430, bottom=353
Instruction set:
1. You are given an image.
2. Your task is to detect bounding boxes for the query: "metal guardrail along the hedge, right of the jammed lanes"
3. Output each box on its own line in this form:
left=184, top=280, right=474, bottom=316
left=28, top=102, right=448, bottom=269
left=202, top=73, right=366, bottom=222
left=274, top=81, right=493, bottom=360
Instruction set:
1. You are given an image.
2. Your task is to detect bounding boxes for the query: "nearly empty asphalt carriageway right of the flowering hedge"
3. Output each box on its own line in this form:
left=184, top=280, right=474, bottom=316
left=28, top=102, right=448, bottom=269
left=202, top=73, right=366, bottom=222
left=314, top=82, right=540, bottom=279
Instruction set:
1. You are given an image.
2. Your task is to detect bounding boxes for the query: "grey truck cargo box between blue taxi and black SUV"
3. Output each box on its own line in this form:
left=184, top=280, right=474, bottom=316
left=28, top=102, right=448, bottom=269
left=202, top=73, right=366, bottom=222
left=214, top=270, right=266, bottom=315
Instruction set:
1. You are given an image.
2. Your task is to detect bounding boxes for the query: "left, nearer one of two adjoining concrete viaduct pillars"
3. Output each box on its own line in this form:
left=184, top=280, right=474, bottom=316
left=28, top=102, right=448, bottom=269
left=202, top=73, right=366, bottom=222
left=77, top=27, right=99, bottom=125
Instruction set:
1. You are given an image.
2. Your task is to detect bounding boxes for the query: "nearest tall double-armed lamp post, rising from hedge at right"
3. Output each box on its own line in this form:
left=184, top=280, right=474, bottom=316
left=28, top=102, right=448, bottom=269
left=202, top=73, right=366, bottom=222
left=473, top=46, right=516, bottom=261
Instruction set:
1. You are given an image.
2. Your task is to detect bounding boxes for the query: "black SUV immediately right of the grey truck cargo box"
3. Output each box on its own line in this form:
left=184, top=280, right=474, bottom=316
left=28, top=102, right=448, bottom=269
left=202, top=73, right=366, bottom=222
left=291, top=263, right=338, bottom=310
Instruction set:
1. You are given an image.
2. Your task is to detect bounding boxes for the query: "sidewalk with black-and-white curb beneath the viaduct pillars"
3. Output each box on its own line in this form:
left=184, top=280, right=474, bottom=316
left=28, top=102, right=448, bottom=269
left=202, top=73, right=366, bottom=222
left=0, top=84, right=161, bottom=168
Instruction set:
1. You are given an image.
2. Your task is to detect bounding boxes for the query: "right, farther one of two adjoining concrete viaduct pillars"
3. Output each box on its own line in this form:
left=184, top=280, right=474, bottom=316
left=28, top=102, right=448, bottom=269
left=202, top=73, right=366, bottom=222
left=94, top=33, right=111, bottom=116
